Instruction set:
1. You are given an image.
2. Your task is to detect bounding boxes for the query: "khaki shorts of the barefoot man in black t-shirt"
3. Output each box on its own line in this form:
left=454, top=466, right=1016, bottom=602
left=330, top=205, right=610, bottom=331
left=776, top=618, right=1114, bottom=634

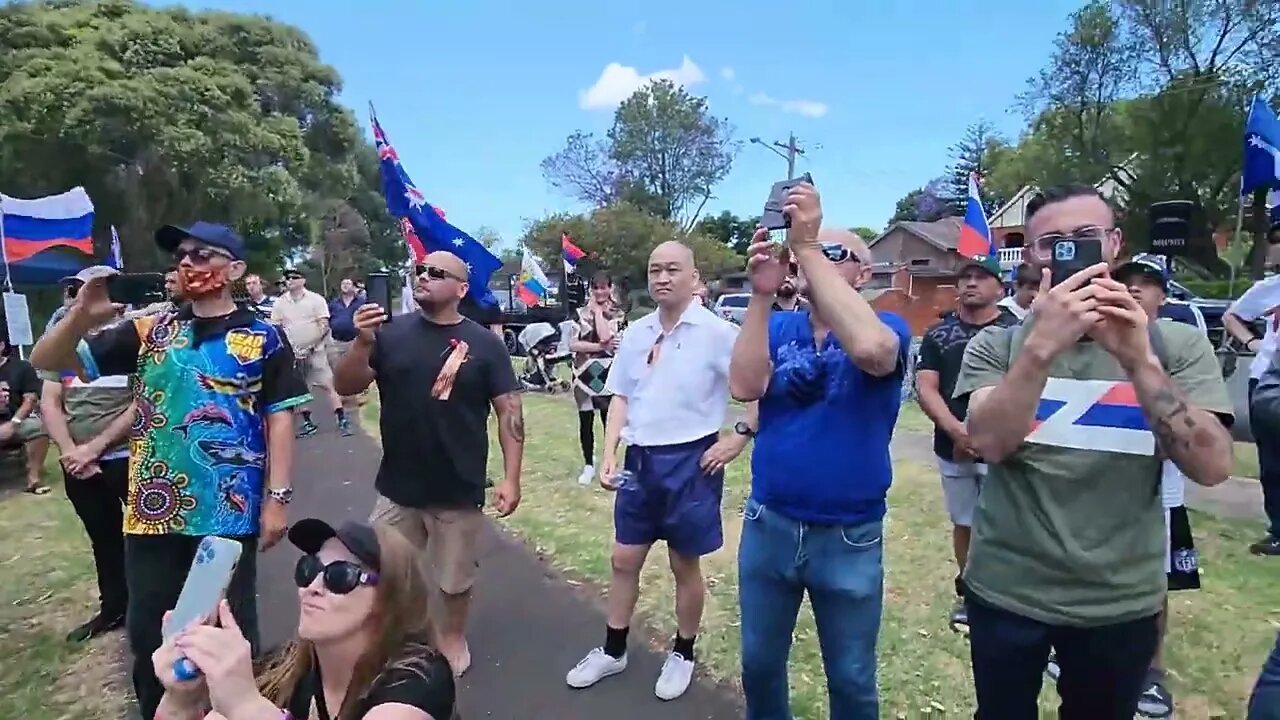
left=369, top=496, right=484, bottom=594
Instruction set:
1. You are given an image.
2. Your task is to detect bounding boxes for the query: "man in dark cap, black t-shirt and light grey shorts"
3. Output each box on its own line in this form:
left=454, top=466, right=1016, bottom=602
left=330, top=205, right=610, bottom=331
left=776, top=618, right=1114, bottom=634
left=915, top=256, right=1013, bottom=632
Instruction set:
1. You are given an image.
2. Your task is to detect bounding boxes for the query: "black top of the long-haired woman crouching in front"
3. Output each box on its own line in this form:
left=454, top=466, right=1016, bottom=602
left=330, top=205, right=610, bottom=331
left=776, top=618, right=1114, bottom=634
left=275, top=640, right=457, bottom=720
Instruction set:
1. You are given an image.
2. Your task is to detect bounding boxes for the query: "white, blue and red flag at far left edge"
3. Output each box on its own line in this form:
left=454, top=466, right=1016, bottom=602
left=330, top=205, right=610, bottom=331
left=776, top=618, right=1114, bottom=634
left=0, top=187, right=93, bottom=265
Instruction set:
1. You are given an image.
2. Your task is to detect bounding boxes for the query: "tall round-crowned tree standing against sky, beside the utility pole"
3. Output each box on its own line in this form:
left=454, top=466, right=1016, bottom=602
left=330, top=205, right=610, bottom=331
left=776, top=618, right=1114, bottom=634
left=541, top=81, right=737, bottom=229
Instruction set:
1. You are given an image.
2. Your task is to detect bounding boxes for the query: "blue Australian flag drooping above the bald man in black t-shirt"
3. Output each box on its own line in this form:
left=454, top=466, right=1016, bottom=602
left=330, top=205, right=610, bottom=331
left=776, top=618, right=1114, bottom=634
left=369, top=105, right=502, bottom=306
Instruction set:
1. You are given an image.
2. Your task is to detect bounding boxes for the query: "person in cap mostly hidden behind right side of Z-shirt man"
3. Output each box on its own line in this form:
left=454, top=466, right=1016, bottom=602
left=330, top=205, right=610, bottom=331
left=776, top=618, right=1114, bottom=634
left=1111, top=258, right=1206, bottom=717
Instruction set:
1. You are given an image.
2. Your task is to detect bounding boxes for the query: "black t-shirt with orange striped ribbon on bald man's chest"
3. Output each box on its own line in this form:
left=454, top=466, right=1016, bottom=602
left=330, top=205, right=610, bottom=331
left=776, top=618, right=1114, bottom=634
left=369, top=314, right=520, bottom=507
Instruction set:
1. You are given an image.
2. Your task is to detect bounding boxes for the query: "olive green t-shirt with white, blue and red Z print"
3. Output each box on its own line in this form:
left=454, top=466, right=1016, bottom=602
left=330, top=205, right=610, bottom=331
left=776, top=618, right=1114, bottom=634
left=955, top=313, right=1231, bottom=626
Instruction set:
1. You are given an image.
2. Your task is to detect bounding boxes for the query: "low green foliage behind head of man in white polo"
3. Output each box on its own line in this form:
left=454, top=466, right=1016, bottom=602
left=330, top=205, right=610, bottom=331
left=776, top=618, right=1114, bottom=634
left=521, top=202, right=744, bottom=288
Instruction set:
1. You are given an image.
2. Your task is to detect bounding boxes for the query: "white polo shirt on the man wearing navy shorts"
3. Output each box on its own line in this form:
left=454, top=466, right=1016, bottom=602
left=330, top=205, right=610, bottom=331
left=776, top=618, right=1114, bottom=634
left=605, top=302, right=737, bottom=447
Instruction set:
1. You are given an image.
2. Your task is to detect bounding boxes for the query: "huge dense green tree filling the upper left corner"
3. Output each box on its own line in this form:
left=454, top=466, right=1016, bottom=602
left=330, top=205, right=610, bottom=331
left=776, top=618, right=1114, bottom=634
left=0, top=0, right=390, bottom=270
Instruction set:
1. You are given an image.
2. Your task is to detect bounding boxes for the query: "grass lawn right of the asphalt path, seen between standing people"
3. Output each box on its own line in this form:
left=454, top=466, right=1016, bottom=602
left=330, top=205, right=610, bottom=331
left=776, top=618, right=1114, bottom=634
left=490, top=395, right=1280, bottom=719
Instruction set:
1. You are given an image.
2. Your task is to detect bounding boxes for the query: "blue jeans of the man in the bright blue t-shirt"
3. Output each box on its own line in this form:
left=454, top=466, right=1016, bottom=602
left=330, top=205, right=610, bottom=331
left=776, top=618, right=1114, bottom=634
left=737, top=500, right=884, bottom=720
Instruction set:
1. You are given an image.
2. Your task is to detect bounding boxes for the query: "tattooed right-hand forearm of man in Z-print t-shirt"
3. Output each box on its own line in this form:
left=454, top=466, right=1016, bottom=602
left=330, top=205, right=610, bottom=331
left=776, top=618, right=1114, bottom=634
left=1129, top=355, right=1231, bottom=486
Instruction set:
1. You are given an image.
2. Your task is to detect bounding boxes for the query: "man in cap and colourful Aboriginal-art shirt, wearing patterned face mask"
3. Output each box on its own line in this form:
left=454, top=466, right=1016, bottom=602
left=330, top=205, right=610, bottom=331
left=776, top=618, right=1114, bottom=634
left=31, top=222, right=310, bottom=717
